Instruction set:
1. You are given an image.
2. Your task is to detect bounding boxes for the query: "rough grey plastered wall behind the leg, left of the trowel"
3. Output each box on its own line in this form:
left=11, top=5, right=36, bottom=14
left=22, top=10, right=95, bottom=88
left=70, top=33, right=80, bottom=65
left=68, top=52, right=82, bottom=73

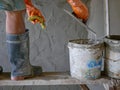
left=0, top=0, right=87, bottom=74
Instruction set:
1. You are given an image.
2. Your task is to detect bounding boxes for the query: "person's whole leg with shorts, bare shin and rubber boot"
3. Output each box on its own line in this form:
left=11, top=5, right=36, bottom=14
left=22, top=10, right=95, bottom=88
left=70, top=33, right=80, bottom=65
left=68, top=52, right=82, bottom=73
left=0, top=0, right=42, bottom=80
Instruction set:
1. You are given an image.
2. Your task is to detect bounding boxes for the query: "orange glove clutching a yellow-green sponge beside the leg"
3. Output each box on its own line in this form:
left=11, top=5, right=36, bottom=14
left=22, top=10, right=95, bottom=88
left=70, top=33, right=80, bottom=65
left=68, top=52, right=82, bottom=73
left=24, top=0, right=45, bottom=28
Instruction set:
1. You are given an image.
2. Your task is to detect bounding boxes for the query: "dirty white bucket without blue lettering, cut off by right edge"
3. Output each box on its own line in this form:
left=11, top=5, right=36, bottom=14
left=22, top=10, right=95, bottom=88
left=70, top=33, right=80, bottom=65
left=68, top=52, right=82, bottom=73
left=105, top=35, right=120, bottom=79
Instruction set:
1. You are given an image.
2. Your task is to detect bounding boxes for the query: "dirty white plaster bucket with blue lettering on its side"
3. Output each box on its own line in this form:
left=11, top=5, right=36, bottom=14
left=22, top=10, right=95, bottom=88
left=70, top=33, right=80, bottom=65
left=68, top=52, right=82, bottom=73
left=68, top=39, right=104, bottom=80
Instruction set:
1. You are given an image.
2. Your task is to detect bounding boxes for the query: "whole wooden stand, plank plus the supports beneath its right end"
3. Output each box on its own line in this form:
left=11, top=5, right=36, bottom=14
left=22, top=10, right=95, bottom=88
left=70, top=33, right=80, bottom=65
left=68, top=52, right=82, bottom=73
left=0, top=72, right=120, bottom=90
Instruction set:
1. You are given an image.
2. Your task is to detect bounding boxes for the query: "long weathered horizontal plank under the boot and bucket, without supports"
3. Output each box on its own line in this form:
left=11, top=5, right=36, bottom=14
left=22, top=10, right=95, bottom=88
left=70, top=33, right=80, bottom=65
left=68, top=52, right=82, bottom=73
left=0, top=72, right=117, bottom=86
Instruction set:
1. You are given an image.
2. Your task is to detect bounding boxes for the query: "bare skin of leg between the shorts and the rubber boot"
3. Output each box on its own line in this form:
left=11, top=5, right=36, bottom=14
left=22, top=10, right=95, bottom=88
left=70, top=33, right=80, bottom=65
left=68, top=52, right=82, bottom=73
left=6, top=10, right=25, bottom=34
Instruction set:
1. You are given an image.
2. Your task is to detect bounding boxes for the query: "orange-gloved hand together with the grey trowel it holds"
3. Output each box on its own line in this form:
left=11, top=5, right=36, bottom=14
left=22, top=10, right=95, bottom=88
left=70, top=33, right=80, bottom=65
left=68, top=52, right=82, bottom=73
left=64, top=0, right=96, bottom=35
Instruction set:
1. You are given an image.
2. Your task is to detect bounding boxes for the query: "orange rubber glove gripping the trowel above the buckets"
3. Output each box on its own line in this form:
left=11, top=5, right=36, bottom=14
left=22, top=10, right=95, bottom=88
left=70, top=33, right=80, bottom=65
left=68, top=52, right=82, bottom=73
left=67, top=0, right=89, bottom=22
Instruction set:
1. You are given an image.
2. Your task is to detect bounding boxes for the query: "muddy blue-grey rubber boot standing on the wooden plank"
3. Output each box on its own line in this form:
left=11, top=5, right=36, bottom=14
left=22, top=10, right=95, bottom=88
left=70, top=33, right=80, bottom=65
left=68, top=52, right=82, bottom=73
left=6, top=30, right=42, bottom=80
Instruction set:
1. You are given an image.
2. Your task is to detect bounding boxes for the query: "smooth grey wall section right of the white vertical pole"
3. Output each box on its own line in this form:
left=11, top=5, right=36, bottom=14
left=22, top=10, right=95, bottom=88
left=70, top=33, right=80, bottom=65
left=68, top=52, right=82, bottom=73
left=109, top=0, right=120, bottom=35
